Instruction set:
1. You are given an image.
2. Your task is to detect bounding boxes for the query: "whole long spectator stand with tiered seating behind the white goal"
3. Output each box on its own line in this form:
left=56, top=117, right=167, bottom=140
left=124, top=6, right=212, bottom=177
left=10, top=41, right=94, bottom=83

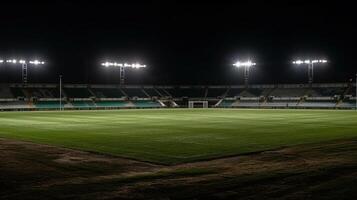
left=0, top=83, right=356, bottom=110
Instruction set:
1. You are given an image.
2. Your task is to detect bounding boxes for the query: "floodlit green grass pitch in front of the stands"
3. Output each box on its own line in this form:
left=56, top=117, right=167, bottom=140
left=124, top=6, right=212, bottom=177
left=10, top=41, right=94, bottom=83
left=0, top=109, right=357, bottom=164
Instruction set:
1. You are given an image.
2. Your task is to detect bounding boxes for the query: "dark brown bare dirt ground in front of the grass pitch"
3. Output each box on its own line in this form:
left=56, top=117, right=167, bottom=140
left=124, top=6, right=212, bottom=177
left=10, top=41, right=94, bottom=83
left=0, top=139, right=357, bottom=199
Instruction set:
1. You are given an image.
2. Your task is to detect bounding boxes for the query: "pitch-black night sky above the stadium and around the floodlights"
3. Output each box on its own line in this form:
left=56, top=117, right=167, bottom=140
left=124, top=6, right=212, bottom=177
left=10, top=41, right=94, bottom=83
left=0, top=0, right=357, bottom=84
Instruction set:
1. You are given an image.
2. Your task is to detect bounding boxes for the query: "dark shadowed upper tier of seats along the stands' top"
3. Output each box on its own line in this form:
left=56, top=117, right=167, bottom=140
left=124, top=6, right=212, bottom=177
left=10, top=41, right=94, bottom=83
left=9, top=87, right=355, bottom=98
